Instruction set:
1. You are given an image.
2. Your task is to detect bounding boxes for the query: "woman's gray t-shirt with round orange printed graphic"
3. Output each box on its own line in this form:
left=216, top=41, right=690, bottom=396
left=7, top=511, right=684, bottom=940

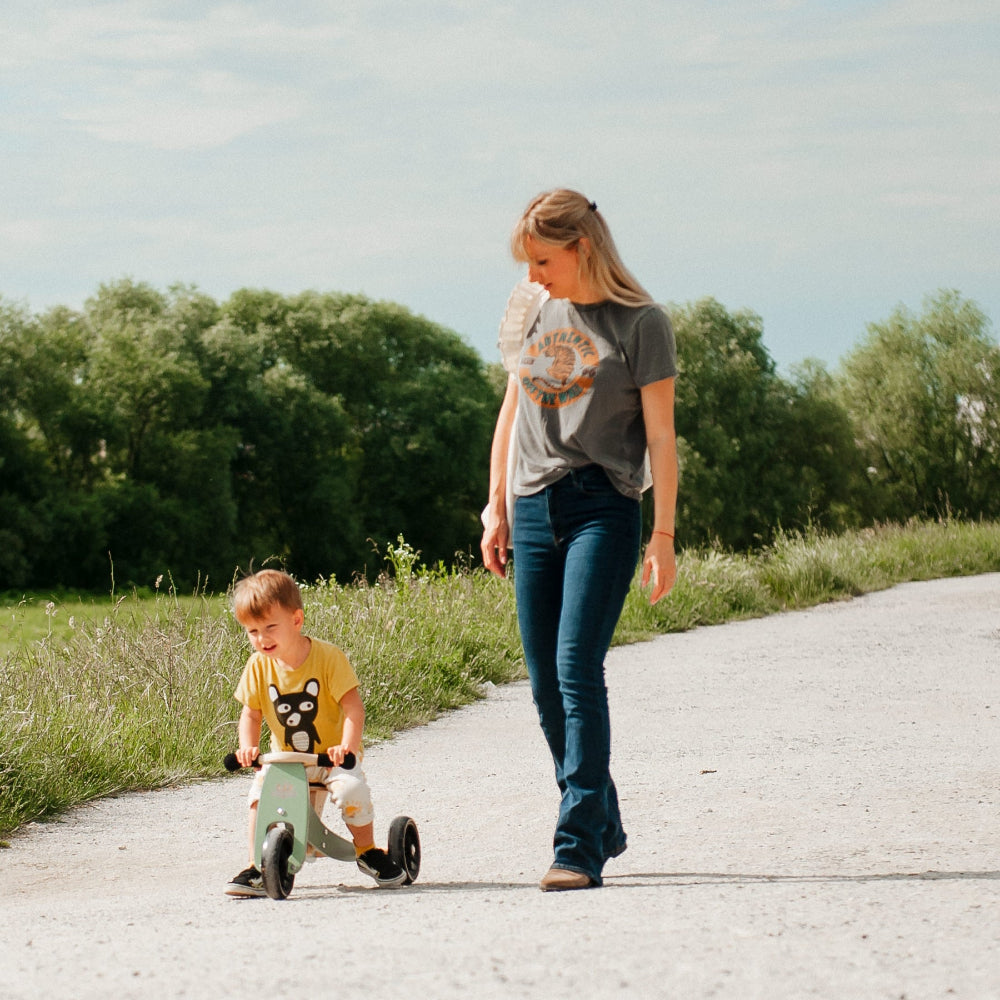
left=514, top=299, right=677, bottom=498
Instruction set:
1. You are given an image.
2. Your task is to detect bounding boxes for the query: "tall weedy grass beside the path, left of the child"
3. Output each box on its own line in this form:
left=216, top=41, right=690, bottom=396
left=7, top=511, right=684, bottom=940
left=0, top=597, right=240, bottom=830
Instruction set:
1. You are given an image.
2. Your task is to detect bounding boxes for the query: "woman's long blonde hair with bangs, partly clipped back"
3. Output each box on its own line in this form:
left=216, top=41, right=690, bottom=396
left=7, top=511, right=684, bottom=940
left=510, top=188, right=653, bottom=306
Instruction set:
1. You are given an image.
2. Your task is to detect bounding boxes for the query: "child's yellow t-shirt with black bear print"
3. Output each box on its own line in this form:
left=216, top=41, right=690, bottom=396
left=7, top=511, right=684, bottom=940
left=234, top=639, right=358, bottom=753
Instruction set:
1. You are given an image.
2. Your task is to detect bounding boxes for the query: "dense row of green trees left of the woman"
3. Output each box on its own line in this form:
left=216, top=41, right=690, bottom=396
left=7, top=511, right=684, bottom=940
left=0, top=281, right=496, bottom=589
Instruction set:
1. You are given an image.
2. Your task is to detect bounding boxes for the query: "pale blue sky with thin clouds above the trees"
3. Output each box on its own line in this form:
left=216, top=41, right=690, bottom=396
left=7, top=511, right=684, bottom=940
left=0, top=0, right=1000, bottom=368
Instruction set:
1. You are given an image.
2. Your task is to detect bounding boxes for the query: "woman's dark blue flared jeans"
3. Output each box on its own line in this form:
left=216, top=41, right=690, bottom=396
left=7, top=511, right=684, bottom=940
left=513, top=465, right=641, bottom=885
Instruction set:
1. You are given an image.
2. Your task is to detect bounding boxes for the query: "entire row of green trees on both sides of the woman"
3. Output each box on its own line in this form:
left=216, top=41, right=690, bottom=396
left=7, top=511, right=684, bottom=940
left=0, top=281, right=1000, bottom=590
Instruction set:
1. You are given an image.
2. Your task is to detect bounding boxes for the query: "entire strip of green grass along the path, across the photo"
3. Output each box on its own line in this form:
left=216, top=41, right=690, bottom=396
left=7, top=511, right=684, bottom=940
left=0, top=522, right=1000, bottom=843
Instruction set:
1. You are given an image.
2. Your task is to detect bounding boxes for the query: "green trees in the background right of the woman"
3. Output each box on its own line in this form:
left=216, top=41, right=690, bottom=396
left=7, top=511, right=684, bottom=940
left=671, top=291, right=1000, bottom=549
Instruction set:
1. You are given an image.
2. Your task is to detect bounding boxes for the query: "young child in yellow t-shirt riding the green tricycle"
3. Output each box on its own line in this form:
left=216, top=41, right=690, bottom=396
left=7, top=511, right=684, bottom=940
left=226, top=569, right=406, bottom=896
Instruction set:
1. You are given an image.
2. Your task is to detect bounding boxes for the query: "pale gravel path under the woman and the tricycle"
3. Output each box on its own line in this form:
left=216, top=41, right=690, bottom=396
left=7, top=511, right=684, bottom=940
left=0, top=574, right=1000, bottom=1000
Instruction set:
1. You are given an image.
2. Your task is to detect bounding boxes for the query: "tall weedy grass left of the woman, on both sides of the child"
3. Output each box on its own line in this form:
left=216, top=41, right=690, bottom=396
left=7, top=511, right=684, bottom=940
left=0, top=540, right=523, bottom=833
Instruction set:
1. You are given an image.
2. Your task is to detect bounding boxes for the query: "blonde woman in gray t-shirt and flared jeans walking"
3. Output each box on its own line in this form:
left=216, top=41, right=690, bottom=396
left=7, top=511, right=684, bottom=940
left=482, top=189, right=677, bottom=890
